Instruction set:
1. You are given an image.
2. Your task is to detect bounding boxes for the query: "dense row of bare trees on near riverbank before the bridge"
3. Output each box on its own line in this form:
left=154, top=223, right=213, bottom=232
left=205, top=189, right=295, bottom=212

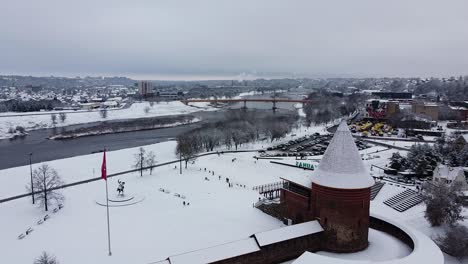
left=176, top=110, right=298, bottom=167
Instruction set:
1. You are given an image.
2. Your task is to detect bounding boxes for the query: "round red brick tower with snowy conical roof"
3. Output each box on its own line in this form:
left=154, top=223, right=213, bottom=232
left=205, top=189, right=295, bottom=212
left=311, top=122, right=374, bottom=252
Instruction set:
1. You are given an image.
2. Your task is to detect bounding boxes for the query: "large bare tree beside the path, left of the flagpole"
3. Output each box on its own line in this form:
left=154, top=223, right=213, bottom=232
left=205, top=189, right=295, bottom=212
left=26, top=164, right=64, bottom=211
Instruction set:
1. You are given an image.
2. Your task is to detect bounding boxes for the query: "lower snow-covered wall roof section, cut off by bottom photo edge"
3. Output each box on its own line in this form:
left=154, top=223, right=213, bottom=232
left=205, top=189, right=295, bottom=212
left=169, top=238, right=260, bottom=264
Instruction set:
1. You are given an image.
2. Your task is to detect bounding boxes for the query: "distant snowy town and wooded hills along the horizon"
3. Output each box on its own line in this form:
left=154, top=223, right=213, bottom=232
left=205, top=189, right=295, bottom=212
left=0, top=76, right=468, bottom=117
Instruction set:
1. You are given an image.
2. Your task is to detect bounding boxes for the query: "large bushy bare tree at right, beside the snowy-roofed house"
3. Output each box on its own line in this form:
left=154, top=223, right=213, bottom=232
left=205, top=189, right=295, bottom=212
left=423, top=182, right=464, bottom=226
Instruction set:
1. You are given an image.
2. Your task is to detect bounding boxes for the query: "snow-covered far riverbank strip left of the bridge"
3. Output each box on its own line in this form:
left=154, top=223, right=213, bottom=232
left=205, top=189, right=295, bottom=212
left=0, top=101, right=216, bottom=139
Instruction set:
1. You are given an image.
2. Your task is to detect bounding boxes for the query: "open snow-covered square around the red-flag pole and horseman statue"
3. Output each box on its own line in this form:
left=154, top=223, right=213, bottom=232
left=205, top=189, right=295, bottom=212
left=0, top=146, right=318, bottom=263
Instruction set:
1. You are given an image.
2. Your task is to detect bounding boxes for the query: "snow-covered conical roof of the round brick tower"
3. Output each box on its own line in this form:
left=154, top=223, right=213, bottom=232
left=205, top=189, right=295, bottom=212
left=312, top=121, right=374, bottom=189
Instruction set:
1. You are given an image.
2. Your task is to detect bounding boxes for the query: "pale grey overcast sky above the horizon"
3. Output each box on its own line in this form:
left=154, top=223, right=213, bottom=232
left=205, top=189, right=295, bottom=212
left=0, top=0, right=468, bottom=79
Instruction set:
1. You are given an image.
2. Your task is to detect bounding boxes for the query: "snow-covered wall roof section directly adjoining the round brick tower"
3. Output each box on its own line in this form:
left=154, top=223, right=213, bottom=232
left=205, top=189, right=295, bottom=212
left=254, top=220, right=323, bottom=247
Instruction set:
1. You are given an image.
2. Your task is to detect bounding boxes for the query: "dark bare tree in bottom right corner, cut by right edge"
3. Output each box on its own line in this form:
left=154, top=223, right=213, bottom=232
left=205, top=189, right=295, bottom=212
left=436, top=225, right=468, bottom=258
